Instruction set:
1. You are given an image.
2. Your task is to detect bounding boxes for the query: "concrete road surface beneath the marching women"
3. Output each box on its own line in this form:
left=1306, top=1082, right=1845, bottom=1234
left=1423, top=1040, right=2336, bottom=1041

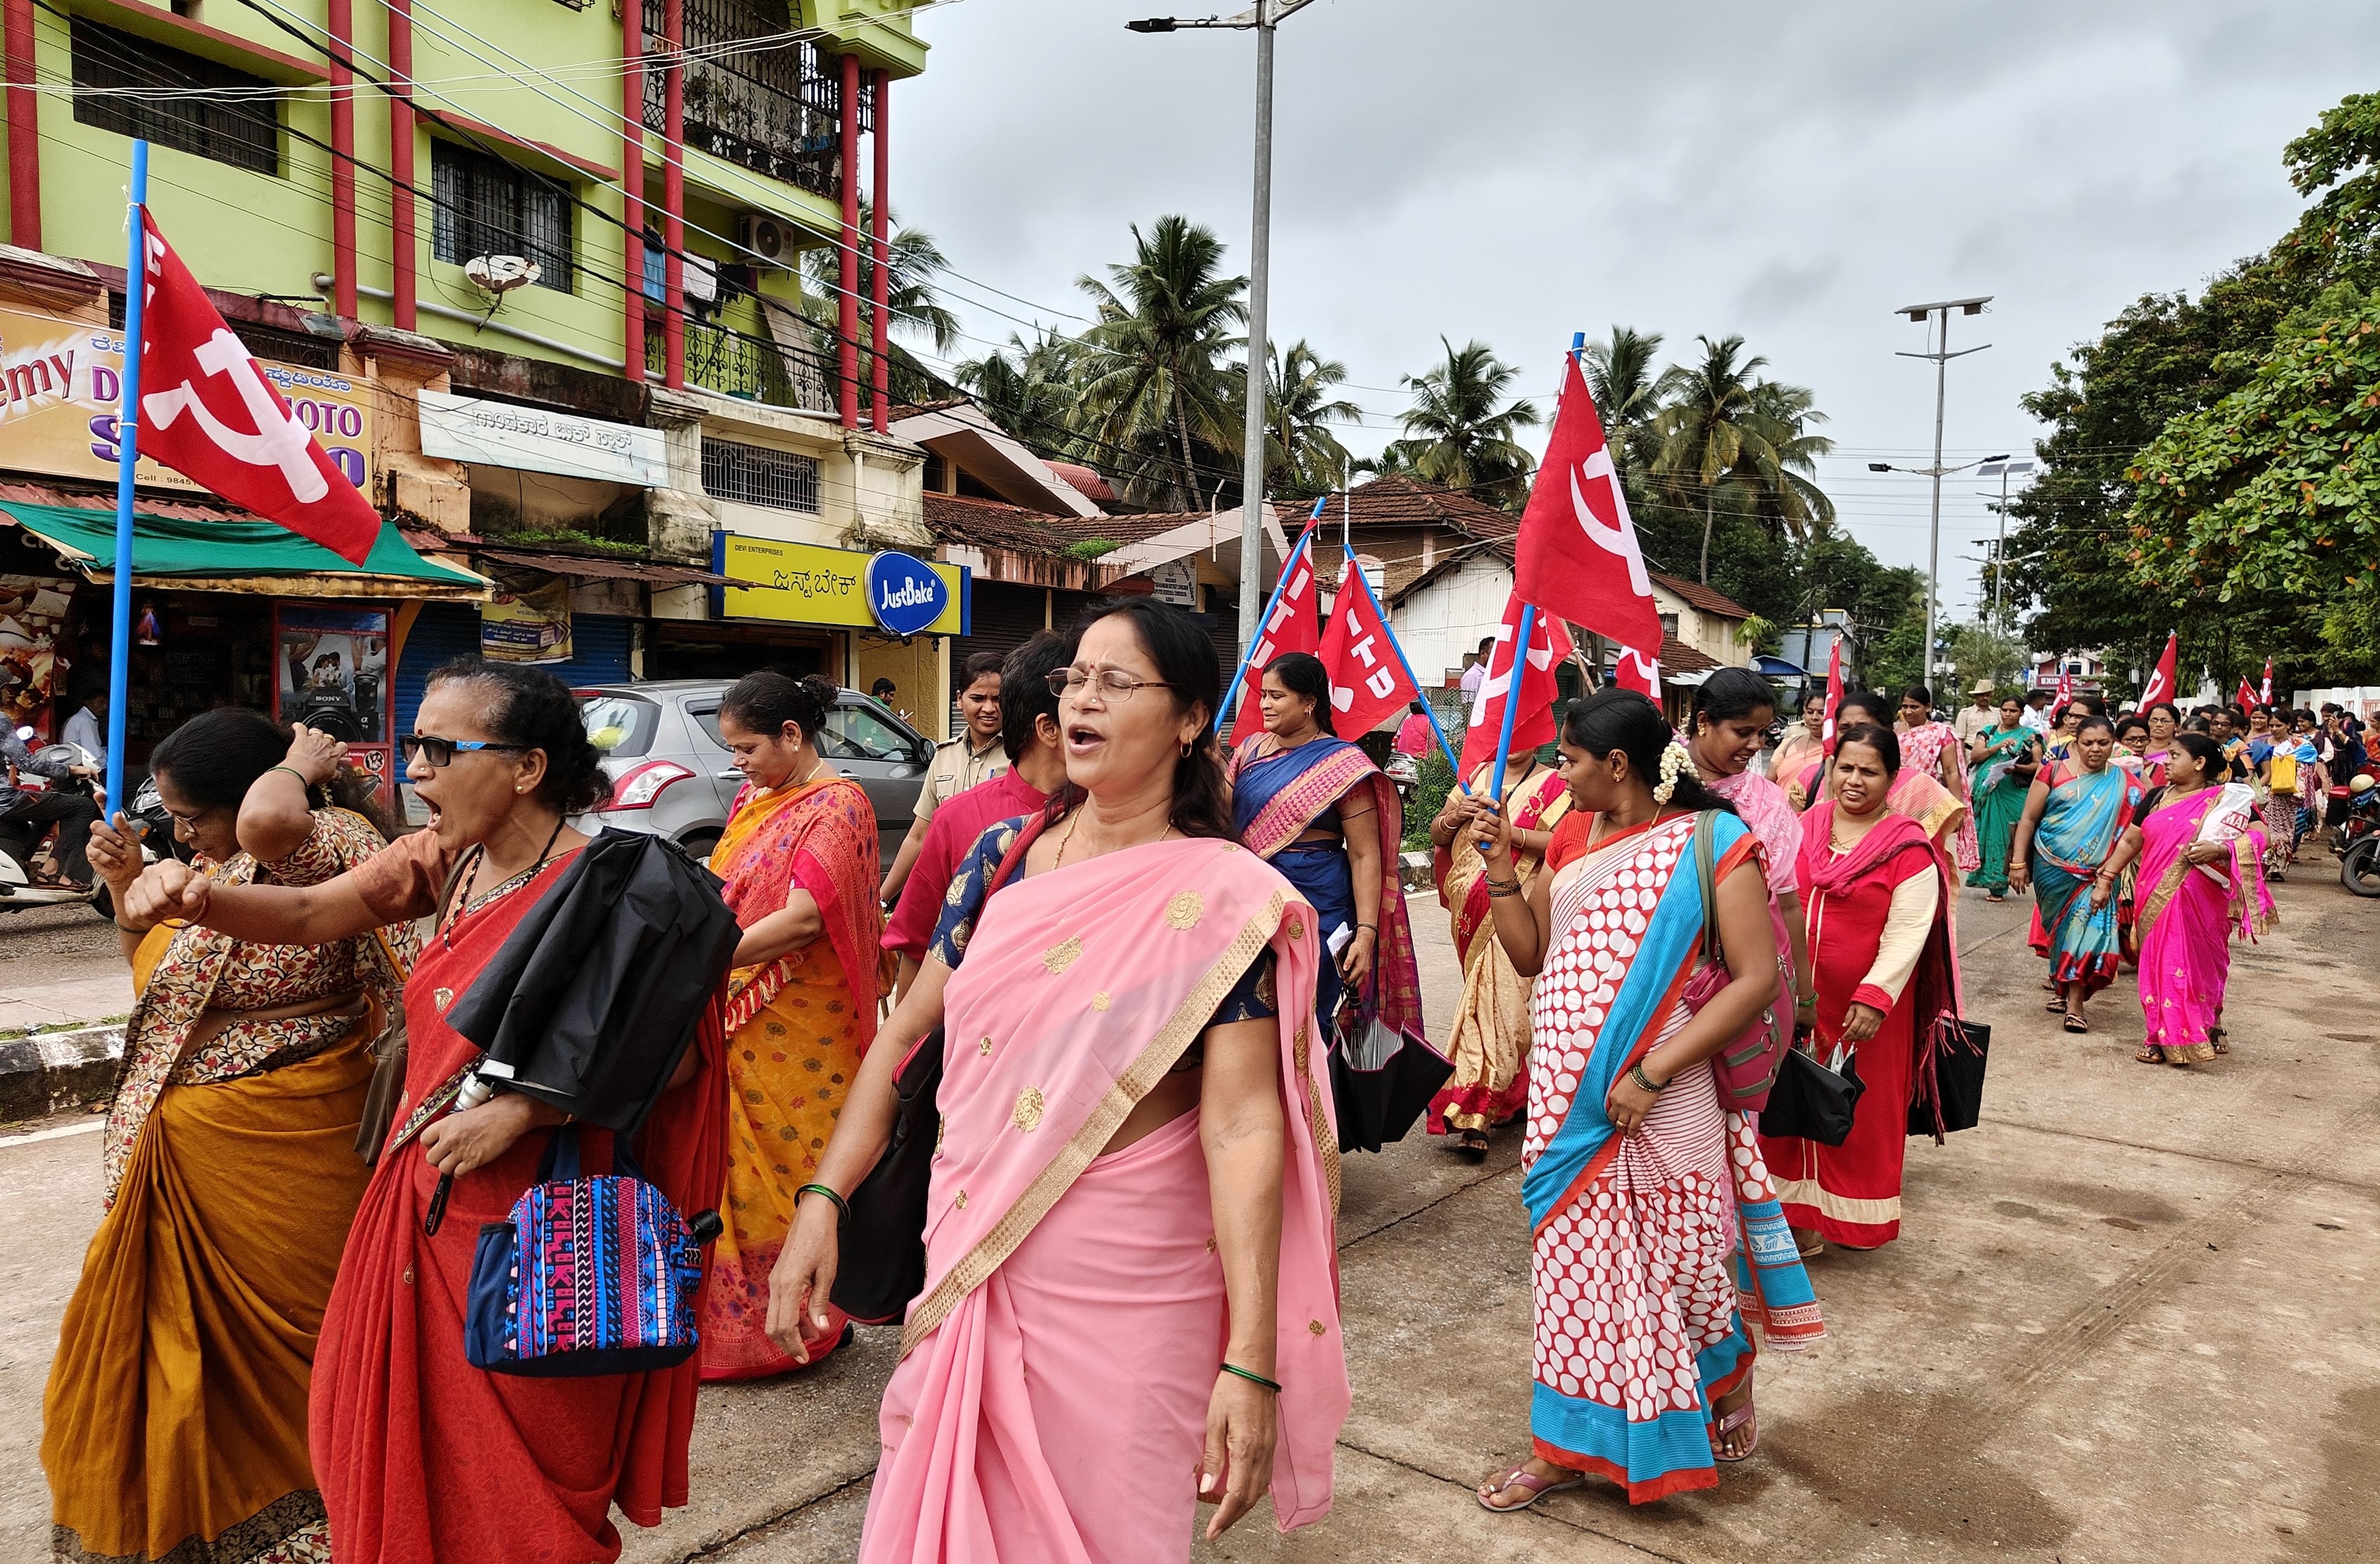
left=0, top=869, right=2380, bottom=1564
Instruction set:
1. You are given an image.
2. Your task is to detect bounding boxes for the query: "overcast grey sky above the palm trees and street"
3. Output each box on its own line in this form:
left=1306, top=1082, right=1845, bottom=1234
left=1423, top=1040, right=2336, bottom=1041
left=893, top=0, right=2380, bottom=610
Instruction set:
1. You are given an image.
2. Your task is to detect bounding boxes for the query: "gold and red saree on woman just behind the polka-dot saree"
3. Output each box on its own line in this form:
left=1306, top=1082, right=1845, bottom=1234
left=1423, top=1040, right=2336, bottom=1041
left=1428, top=767, right=1571, bottom=1135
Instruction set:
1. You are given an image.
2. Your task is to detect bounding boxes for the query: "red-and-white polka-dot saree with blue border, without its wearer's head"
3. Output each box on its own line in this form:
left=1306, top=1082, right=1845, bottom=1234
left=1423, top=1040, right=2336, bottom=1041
left=1521, top=814, right=1825, bottom=1505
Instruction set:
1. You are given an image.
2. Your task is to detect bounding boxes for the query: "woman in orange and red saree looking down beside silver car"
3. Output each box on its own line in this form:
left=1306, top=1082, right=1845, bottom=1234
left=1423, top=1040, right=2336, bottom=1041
left=702, top=674, right=883, bottom=1381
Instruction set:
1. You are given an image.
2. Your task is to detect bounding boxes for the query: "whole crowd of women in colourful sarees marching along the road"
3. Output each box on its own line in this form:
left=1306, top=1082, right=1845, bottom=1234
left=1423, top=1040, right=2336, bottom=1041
left=43, top=588, right=2368, bottom=1564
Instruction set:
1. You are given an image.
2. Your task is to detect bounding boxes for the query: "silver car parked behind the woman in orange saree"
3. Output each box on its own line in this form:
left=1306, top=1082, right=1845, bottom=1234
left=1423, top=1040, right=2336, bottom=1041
left=571, top=678, right=933, bottom=869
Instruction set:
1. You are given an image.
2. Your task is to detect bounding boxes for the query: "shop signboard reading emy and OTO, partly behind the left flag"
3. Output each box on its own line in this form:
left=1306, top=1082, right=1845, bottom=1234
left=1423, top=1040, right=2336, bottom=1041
left=0, top=309, right=371, bottom=491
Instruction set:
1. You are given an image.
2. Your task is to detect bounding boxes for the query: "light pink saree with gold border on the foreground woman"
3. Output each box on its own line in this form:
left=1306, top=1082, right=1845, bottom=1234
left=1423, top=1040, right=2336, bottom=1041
left=859, top=840, right=1347, bottom=1564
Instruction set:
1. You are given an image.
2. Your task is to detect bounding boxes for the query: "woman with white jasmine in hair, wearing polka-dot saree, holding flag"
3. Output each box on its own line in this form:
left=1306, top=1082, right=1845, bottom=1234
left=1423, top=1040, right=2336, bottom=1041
left=1476, top=688, right=1823, bottom=1511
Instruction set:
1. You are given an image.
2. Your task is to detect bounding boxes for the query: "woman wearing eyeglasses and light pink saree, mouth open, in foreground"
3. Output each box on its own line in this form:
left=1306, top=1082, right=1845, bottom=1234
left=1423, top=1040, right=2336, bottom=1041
left=769, top=597, right=1347, bottom=1564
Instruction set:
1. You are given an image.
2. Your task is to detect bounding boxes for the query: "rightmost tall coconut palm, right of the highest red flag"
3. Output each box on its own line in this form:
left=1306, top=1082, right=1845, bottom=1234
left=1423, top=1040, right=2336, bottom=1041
left=1652, top=335, right=1835, bottom=586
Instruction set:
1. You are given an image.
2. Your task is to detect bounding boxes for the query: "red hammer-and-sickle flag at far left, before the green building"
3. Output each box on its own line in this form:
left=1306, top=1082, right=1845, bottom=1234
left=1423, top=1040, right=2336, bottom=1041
left=141, top=209, right=381, bottom=564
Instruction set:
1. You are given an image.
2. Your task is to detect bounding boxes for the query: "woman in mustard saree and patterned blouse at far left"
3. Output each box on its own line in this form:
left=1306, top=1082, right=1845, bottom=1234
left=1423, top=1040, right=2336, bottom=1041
left=40, top=707, right=417, bottom=1559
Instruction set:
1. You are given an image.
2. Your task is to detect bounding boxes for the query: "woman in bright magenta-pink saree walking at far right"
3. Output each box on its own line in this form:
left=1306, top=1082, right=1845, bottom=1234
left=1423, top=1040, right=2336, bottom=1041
left=2109, top=733, right=2275, bottom=1066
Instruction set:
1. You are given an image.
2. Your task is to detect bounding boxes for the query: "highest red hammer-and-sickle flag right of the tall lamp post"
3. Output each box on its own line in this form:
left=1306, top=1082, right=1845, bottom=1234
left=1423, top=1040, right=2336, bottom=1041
left=1514, top=352, right=1661, bottom=648
